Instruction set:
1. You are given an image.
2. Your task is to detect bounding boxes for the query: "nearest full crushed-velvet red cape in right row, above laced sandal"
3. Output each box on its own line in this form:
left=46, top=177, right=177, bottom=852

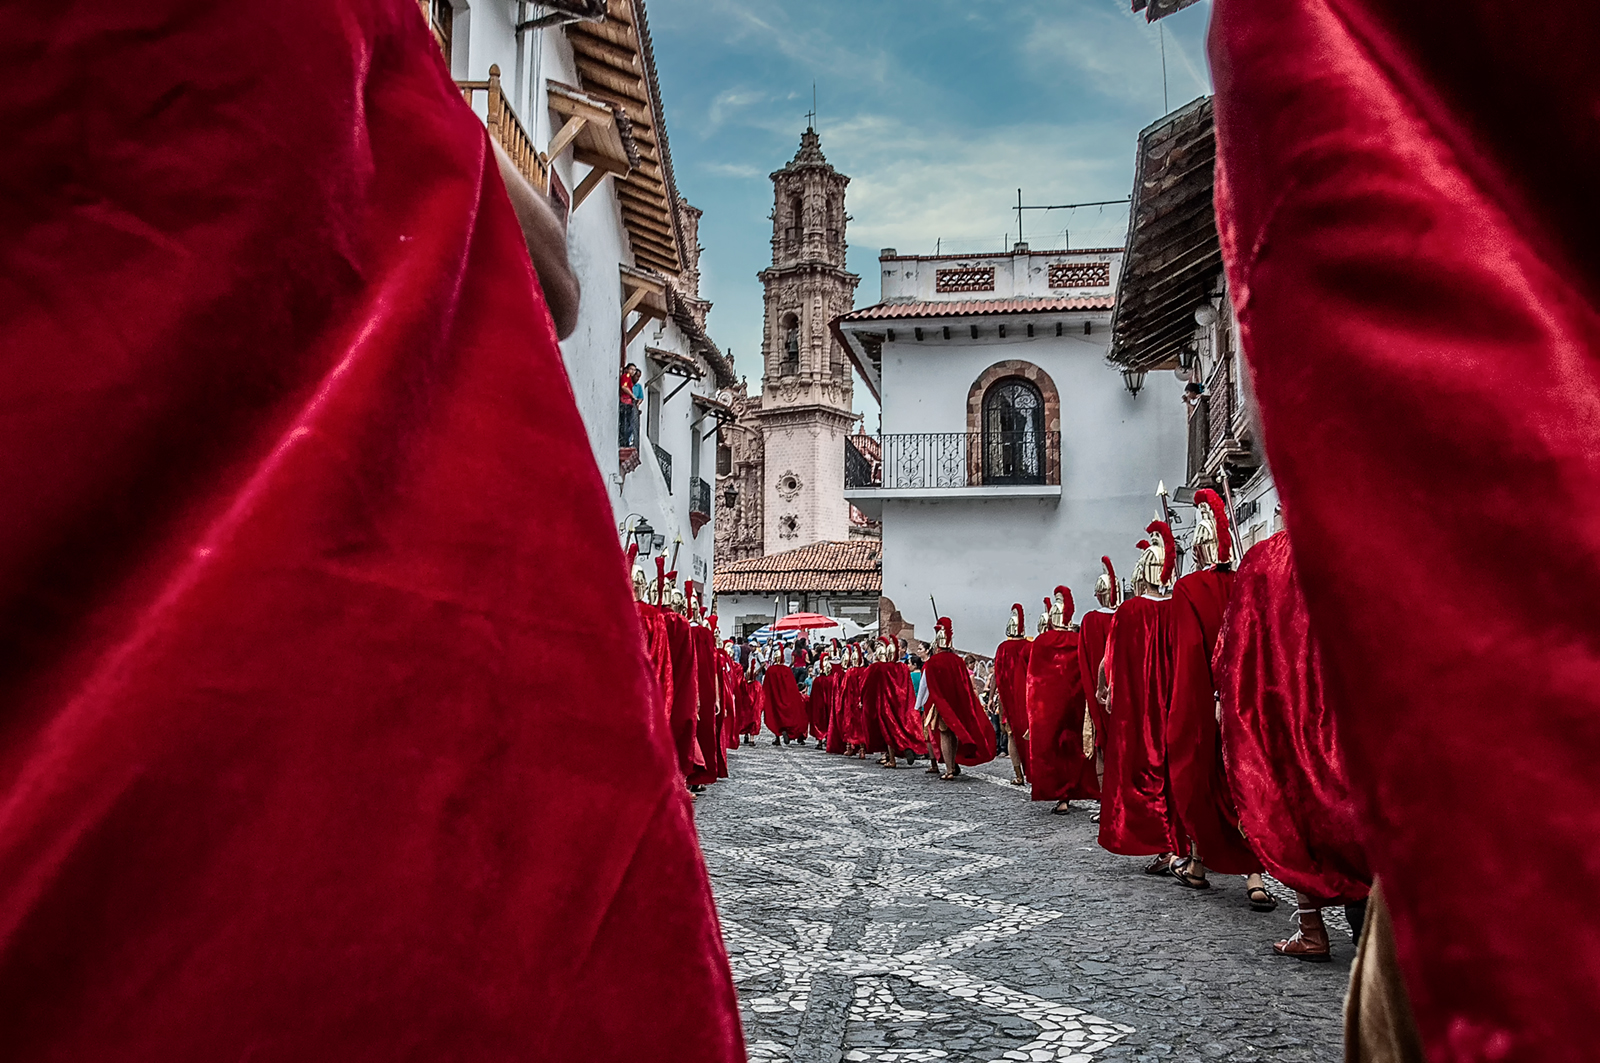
left=1214, top=532, right=1373, bottom=905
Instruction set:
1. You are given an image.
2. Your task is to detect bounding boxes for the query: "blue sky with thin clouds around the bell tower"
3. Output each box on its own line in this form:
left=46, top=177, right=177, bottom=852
left=650, top=0, right=1211, bottom=416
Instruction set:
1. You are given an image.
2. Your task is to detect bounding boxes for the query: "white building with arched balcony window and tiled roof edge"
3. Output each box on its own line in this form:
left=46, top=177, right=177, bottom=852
left=834, top=243, right=1186, bottom=653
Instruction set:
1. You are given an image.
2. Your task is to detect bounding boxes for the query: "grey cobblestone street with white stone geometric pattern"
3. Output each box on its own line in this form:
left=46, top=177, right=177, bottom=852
left=696, top=738, right=1354, bottom=1063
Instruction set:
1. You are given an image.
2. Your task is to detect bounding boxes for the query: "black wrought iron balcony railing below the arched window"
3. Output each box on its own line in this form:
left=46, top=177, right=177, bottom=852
left=845, top=429, right=1061, bottom=490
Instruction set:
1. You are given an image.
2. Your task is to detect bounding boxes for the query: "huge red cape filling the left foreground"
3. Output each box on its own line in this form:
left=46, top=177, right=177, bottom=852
left=0, top=0, right=744, bottom=1063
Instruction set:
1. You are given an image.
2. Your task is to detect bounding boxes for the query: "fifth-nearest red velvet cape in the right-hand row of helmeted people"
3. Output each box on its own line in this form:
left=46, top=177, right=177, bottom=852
left=1027, top=631, right=1099, bottom=800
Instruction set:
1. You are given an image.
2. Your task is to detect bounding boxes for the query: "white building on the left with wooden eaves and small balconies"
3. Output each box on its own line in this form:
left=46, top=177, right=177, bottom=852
left=419, top=0, right=734, bottom=598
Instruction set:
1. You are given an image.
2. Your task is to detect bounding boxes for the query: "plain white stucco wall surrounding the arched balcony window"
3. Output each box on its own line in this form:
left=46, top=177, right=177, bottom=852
left=883, top=312, right=1187, bottom=653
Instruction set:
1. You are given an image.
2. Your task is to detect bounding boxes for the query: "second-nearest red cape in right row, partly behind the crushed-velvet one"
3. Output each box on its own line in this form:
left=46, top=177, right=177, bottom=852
left=1166, top=568, right=1261, bottom=874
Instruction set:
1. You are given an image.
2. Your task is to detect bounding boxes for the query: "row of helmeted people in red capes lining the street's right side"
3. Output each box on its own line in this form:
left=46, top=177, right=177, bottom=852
left=995, top=488, right=1373, bottom=962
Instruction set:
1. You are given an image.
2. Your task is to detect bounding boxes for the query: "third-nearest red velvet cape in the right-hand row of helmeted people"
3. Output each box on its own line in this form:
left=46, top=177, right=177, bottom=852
left=1099, top=597, right=1186, bottom=856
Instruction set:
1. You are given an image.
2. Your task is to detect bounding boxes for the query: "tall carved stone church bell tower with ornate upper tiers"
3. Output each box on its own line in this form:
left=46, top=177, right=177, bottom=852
left=757, top=130, right=861, bottom=554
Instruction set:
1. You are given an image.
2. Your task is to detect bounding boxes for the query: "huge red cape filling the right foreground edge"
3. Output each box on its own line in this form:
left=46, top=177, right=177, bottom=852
left=1211, top=0, right=1600, bottom=1063
